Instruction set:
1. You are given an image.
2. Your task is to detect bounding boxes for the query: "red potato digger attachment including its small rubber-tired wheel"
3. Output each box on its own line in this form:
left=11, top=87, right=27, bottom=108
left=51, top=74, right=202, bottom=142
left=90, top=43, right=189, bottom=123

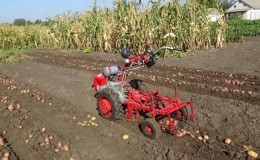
left=124, top=87, right=194, bottom=139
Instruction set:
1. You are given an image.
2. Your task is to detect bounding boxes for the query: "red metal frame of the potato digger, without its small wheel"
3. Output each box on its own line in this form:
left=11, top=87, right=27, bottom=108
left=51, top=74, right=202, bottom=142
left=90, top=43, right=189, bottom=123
left=124, top=87, right=194, bottom=134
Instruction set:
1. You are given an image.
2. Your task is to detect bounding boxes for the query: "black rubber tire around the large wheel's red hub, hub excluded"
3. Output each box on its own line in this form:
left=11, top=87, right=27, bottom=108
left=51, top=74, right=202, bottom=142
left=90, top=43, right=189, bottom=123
left=97, top=88, right=123, bottom=121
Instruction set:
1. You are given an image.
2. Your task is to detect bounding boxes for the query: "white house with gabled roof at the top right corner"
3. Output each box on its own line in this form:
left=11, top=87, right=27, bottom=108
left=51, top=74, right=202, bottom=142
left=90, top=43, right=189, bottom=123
left=225, top=0, right=260, bottom=20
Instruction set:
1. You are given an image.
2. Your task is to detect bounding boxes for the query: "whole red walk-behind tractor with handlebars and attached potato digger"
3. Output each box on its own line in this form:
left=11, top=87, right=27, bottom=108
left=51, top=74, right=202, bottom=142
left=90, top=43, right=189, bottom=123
left=93, top=47, right=194, bottom=139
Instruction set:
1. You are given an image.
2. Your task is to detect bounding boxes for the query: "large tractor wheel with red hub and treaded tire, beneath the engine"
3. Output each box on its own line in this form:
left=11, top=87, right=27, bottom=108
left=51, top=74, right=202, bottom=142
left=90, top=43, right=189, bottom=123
left=97, top=88, right=123, bottom=121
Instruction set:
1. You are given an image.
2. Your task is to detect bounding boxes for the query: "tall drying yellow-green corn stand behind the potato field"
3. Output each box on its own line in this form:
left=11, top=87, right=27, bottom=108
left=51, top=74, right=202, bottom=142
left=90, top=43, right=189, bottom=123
left=0, top=0, right=226, bottom=52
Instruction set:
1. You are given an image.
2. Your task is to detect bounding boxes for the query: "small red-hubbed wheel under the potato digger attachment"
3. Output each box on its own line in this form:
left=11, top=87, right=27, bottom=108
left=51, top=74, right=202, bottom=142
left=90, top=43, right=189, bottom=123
left=141, top=118, right=162, bottom=139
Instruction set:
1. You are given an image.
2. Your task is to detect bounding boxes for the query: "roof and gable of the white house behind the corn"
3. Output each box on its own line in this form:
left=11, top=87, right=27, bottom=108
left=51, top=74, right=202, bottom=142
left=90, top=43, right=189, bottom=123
left=225, top=0, right=260, bottom=13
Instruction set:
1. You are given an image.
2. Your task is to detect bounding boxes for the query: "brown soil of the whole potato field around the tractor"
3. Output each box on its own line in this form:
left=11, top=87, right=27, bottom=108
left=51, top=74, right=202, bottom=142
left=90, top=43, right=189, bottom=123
left=0, top=37, right=260, bottom=160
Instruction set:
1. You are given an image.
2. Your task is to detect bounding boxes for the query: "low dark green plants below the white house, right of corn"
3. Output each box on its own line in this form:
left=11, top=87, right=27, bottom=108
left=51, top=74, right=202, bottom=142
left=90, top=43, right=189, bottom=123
left=226, top=20, right=260, bottom=43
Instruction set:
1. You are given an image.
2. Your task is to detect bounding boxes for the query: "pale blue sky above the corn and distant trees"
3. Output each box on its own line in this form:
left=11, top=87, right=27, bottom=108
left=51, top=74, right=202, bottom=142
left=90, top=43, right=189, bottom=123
left=0, top=0, right=148, bottom=23
